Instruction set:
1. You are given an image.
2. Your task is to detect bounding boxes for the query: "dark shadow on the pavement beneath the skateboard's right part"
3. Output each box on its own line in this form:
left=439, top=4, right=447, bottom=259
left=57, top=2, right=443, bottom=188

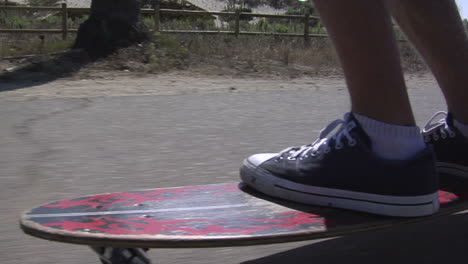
left=243, top=213, right=468, bottom=264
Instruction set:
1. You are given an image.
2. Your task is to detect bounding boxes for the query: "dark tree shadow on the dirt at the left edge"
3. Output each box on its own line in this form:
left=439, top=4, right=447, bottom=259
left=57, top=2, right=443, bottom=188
left=0, top=50, right=93, bottom=92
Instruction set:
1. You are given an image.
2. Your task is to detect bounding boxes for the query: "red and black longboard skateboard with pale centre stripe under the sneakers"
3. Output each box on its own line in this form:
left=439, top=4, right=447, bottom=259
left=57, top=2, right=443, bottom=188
left=20, top=177, right=468, bottom=264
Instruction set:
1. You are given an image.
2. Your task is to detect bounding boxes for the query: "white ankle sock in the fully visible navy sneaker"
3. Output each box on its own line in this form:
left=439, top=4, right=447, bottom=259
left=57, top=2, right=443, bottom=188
left=353, top=113, right=426, bottom=160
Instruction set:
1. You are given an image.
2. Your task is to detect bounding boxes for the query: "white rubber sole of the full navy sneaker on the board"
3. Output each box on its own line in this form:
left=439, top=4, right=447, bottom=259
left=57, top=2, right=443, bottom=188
left=240, top=160, right=439, bottom=217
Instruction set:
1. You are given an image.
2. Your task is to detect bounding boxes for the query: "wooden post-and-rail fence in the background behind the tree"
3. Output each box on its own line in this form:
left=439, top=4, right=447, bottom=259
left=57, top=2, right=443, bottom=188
left=0, top=3, right=328, bottom=41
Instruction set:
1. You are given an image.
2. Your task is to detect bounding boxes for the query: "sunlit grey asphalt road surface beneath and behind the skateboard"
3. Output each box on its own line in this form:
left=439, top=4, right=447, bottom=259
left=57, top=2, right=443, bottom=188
left=0, top=79, right=468, bottom=264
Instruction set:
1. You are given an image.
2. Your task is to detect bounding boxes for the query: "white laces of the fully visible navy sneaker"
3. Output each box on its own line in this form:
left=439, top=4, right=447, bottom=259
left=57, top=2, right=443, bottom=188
left=278, top=113, right=357, bottom=160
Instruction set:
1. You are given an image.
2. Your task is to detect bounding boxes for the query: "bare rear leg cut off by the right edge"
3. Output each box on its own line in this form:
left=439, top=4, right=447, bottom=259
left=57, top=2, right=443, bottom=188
left=387, top=0, right=468, bottom=124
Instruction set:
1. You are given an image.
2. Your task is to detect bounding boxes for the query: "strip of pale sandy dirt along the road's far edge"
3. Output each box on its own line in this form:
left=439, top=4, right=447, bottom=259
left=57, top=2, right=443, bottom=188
left=0, top=67, right=435, bottom=101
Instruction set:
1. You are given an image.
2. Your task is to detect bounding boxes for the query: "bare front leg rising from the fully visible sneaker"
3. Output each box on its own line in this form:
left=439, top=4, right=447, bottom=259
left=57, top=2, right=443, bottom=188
left=315, top=0, right=415, bottom=126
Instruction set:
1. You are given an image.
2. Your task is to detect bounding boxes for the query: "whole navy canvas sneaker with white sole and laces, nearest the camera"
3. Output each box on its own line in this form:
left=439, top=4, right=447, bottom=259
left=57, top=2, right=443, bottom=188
left=240, top=113, right=439, bottom=217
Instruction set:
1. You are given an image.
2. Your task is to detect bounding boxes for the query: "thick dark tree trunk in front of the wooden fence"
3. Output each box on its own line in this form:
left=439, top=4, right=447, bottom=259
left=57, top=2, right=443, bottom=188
left=74, top=0, right=150, bottom=56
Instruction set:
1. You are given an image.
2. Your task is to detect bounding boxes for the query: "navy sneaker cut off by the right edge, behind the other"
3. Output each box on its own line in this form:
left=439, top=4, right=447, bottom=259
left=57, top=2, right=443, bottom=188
left=422, top=111, right=468, bottom=178
